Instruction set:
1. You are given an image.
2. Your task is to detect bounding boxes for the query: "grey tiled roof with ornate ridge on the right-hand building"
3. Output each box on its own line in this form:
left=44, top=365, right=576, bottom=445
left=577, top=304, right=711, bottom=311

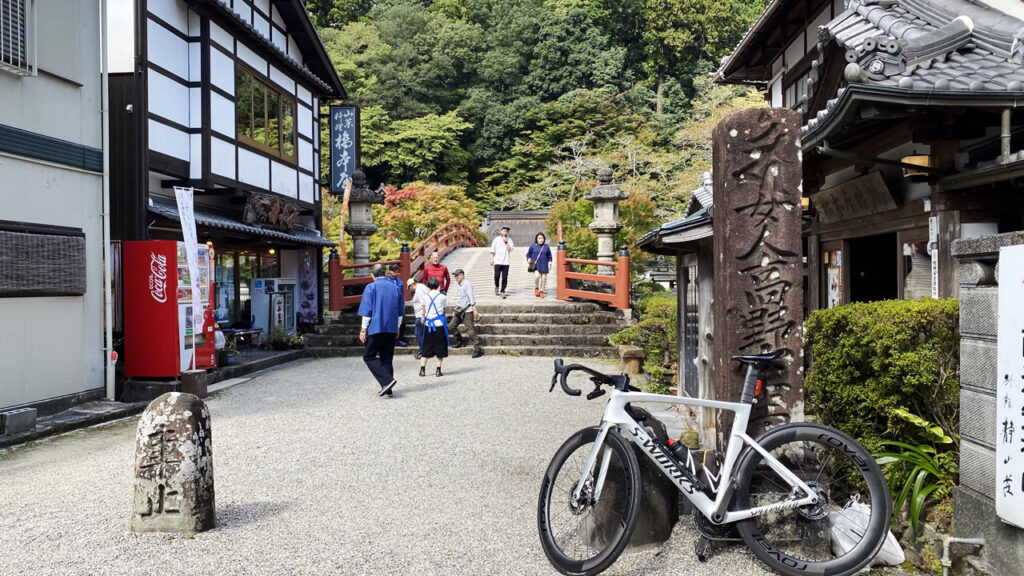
left=804, top=0, right=1024, bottom=132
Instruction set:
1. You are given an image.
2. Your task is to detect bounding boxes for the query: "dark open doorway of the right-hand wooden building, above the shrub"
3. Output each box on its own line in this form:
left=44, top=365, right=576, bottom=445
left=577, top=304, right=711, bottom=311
left=849, top=233, right=899, bottom=302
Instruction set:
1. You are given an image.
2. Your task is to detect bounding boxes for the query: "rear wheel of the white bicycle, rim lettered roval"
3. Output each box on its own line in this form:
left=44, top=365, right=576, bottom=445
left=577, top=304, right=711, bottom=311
left=735, top=422, right=892, bottom=576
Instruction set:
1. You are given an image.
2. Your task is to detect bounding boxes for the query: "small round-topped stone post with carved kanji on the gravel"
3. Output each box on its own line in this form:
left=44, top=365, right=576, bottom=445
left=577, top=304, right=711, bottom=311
left=131, top=393, right=216, bottom=534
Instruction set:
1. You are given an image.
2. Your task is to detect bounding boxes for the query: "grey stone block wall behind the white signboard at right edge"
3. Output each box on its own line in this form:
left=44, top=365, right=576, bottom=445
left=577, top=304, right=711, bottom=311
left=952, top=232, right=1024, bottom=574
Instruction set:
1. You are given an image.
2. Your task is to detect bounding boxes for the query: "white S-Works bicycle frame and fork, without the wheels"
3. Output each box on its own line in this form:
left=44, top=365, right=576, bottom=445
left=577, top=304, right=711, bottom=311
left=572, top=390, right=817, bottom=524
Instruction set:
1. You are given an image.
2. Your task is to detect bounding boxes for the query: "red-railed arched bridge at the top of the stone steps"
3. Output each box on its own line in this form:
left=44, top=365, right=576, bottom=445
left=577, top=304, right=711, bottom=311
left=328, top=222, right=630, bottom=312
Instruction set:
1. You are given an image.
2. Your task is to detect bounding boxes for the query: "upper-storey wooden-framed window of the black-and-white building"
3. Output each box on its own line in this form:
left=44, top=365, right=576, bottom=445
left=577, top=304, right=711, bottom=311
left=234, top=67, right=295, bottom=162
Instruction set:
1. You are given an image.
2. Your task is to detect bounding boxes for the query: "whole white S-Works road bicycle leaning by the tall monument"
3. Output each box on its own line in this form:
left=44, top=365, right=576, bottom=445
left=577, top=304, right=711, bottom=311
left=537, top=352, right=892, bottom=576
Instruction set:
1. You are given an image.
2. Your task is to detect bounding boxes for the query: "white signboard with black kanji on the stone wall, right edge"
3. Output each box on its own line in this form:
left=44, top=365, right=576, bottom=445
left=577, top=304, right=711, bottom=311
left=995, top=239, right=1024, bottom=528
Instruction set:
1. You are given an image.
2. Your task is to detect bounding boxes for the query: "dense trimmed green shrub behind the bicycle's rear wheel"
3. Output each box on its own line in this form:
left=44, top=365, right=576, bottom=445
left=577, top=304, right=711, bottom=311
left=804, top=299, right=959, bottom=451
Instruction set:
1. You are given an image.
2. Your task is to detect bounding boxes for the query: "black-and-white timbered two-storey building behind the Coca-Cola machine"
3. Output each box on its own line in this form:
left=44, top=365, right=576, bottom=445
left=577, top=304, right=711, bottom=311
left=110, top=0, right=346, bottom=336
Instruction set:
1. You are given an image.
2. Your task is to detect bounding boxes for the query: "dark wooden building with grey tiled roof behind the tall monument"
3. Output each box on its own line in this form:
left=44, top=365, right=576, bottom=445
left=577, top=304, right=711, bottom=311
left=719, top=0, right=1024, bottom=311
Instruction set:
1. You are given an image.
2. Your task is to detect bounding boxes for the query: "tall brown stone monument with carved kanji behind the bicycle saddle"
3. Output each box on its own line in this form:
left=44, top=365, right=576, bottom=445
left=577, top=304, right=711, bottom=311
left=711, top=108, right=804, bottom=446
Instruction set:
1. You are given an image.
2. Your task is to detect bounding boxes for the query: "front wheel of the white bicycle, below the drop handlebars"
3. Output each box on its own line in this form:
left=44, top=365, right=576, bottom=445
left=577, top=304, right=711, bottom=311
left=537, top=427, right=640, bottom=576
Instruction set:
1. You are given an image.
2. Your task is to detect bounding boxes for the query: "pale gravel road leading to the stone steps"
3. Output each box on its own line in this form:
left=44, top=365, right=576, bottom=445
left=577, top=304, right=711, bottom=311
left=0, top=357, right=839, bottom=576
